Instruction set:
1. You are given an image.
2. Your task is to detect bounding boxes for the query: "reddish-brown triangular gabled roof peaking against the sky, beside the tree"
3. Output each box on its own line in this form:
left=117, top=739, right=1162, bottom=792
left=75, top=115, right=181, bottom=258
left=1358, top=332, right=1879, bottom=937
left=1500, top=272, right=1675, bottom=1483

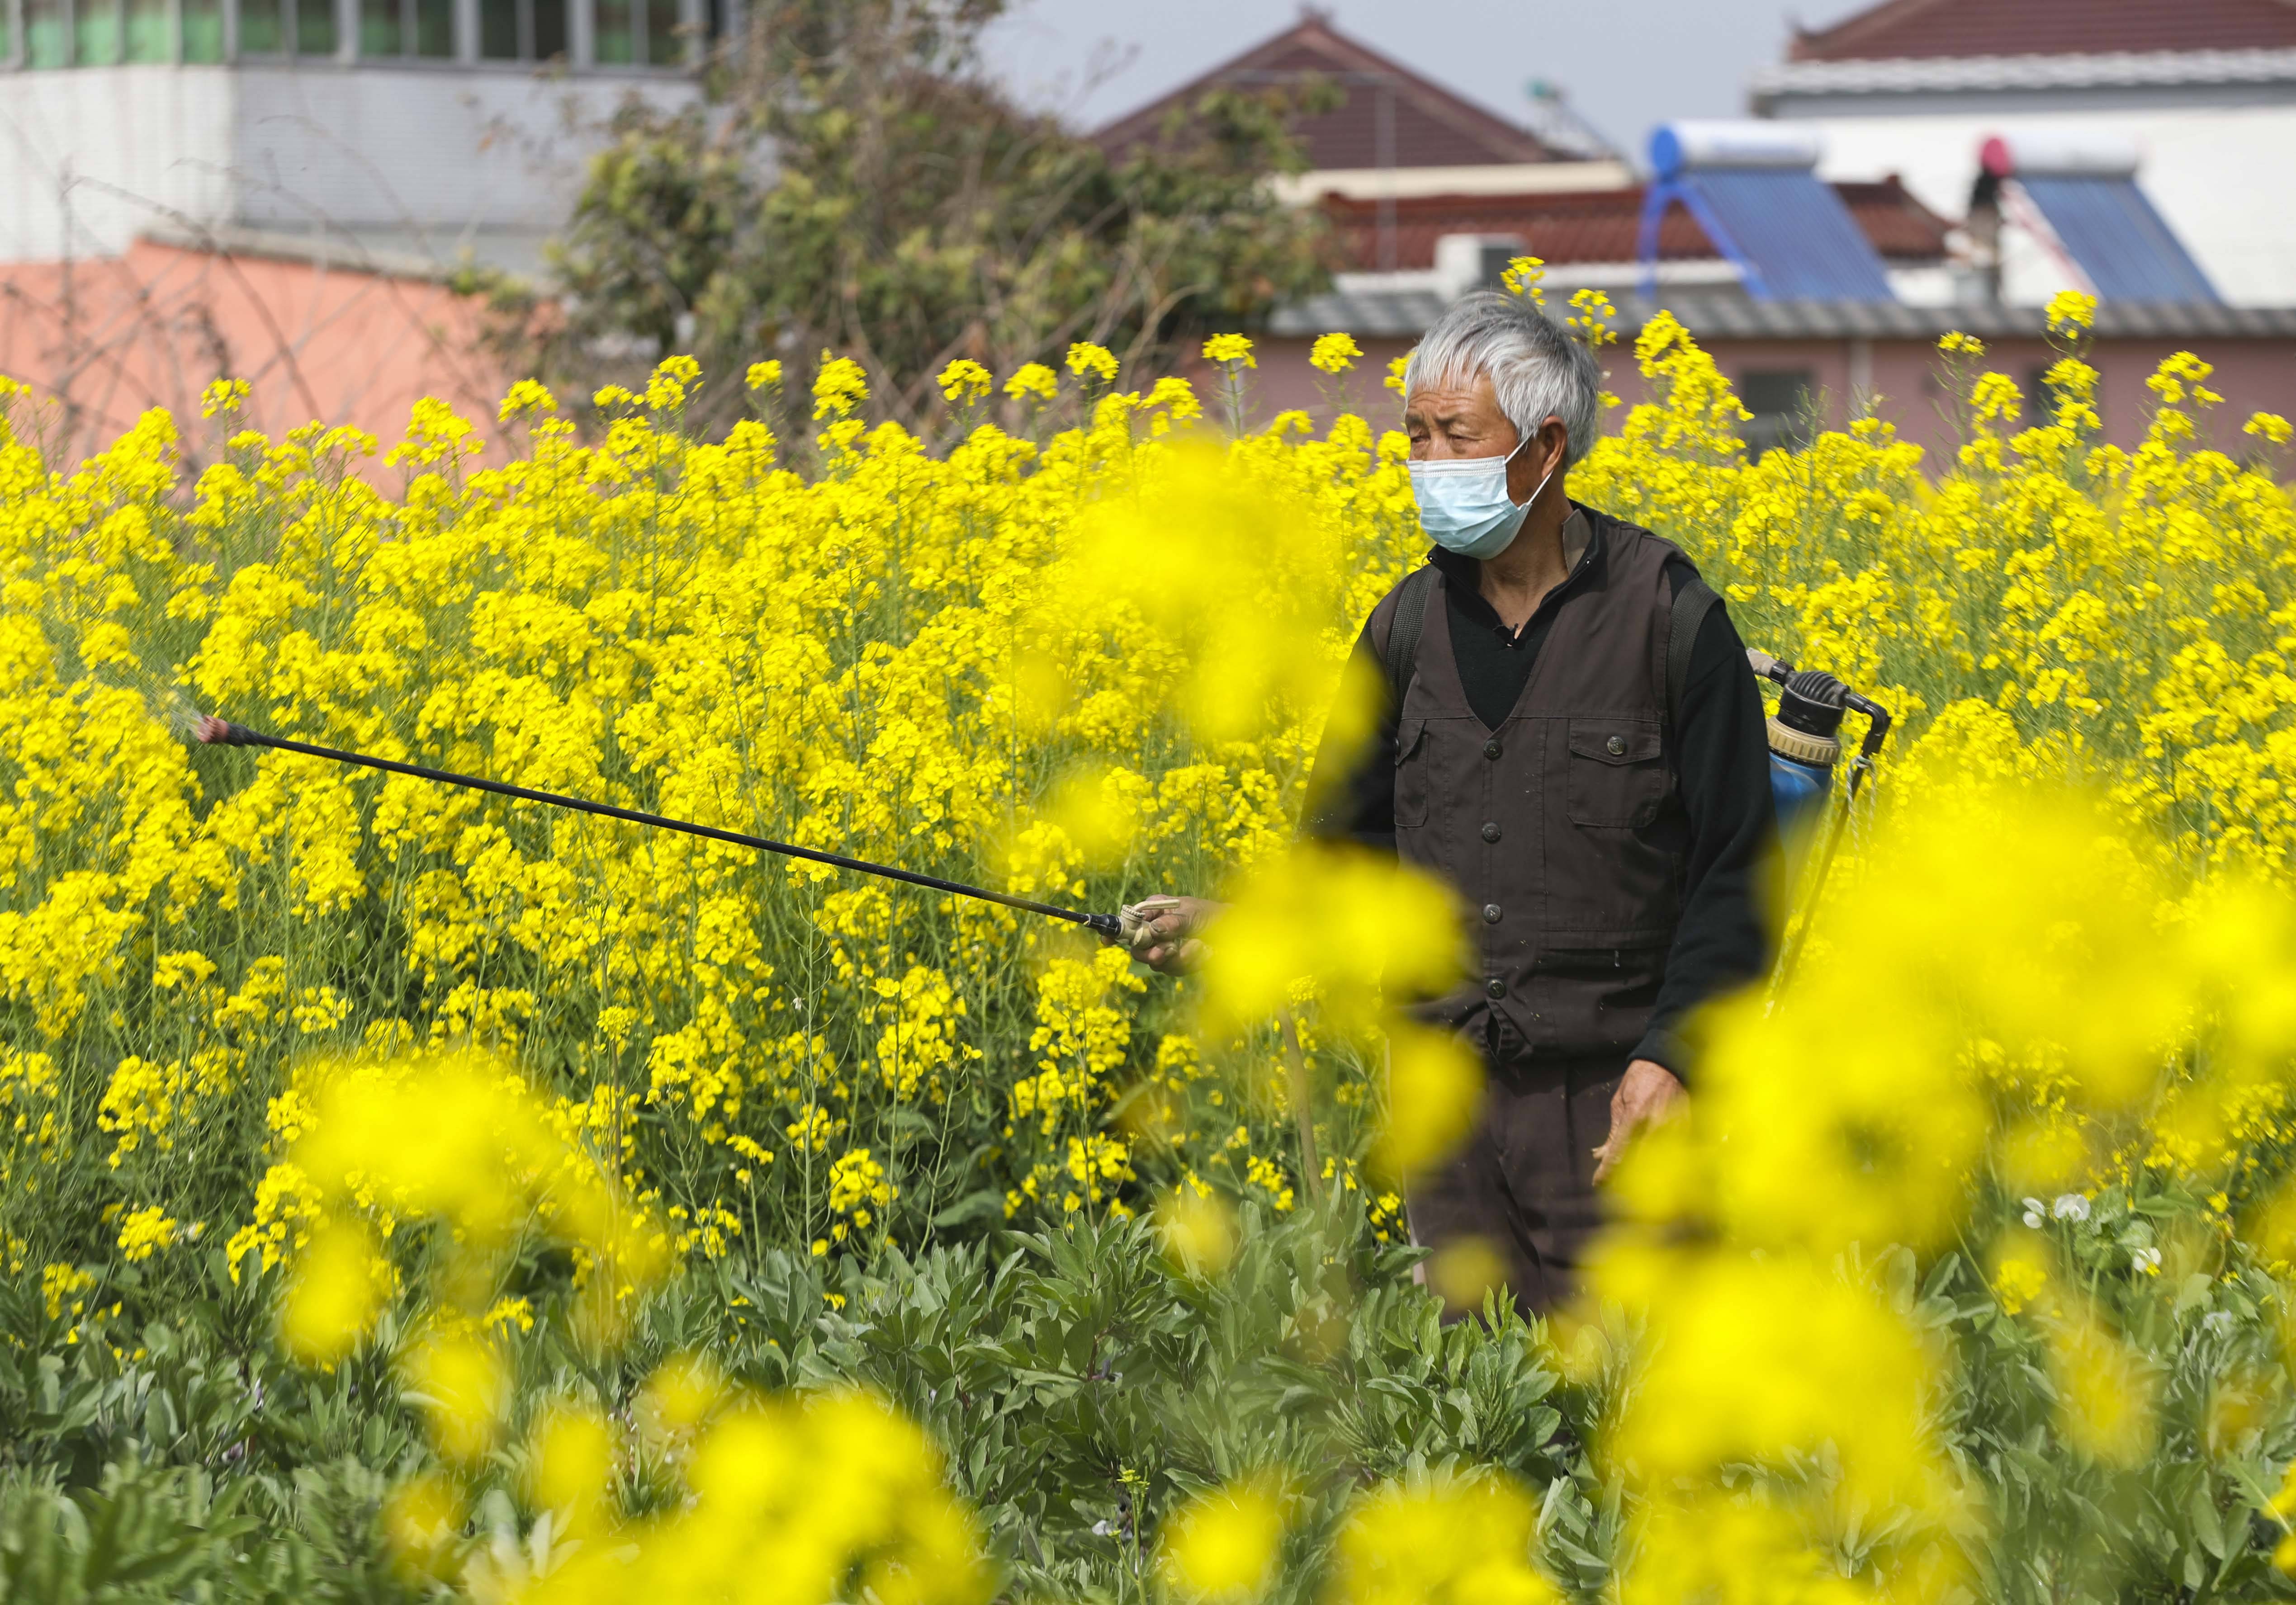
left=1095, top=11, right=1571, bottom=168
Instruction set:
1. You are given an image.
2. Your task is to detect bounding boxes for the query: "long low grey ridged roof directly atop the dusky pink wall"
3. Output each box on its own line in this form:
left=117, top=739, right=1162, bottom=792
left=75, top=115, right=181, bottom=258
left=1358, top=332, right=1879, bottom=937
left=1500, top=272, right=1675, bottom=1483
left=1270, top=292, right=2296, bottom=340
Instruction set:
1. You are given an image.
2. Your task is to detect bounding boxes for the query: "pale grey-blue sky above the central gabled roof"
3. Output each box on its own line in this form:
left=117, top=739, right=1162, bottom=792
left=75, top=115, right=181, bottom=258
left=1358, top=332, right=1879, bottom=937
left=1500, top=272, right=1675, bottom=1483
left=989, top=0, right=1871, bottom=161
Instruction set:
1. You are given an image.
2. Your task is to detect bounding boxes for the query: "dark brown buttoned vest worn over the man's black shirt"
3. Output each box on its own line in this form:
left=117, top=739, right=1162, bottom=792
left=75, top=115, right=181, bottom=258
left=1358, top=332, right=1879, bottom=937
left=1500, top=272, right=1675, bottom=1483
left=1373, top=510, right=1688, bottom=1056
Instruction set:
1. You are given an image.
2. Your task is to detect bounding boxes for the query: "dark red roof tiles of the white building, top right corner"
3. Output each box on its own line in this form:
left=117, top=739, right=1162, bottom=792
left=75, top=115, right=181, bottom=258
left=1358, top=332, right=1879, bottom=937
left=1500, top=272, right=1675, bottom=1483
left=1789, top=0, right=2296, bottom=62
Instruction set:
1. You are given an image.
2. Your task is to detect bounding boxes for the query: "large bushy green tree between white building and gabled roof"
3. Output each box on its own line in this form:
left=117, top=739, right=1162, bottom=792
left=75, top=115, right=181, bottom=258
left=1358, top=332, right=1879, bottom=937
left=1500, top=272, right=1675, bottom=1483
left=498, top=0, right=1327, bottom=425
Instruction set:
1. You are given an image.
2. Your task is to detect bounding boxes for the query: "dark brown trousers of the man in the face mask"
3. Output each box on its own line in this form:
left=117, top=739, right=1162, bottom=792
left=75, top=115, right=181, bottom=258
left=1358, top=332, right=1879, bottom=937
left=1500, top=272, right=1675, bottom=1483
left=1410, top=1052, right=1626, bottom=1316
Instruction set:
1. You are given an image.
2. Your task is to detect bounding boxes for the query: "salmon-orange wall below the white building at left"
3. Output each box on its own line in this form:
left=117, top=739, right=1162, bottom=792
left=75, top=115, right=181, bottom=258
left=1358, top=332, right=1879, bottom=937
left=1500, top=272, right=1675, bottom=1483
left=0, top=241, right=505, bottom=475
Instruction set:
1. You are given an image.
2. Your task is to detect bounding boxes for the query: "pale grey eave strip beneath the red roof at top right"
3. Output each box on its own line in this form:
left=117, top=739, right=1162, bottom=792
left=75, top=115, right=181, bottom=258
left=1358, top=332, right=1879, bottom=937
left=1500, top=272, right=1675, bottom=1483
left=1747, top=48, right=2296, bottom=106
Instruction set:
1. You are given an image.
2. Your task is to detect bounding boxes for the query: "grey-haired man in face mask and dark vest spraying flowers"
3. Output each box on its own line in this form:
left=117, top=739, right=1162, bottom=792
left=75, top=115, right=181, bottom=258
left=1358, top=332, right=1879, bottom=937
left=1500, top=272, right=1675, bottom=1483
left=1134, top=294, right=1775, bottom=1311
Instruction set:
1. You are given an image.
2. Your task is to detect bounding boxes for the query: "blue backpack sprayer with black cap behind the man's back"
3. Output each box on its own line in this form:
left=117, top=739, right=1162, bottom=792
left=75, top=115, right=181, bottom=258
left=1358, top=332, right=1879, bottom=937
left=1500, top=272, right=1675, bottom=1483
left=1745, top=647, right=1889, bottom=994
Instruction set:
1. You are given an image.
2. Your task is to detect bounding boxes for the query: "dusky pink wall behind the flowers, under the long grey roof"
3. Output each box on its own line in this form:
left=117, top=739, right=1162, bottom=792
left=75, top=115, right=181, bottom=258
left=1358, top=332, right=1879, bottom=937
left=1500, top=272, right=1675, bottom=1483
left=1249, top=340, right=2296, bottom=466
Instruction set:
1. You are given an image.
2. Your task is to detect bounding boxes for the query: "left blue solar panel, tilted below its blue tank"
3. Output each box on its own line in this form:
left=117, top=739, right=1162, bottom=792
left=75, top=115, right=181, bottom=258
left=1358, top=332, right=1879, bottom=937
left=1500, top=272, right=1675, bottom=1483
left=1667, top=168, right=1897, bottom=301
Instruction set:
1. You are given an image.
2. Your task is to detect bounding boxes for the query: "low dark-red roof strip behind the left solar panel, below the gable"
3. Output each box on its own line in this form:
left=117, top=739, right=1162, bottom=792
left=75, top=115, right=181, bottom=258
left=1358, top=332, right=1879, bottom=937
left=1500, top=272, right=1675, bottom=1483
left=1322, top=177, right=1951, bottom=271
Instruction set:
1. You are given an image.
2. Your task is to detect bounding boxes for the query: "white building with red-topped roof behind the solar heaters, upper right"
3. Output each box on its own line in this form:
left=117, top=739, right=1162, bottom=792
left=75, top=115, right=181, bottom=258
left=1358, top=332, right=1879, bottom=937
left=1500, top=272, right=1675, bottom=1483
left=1750, top=0, right=2296, bottom=308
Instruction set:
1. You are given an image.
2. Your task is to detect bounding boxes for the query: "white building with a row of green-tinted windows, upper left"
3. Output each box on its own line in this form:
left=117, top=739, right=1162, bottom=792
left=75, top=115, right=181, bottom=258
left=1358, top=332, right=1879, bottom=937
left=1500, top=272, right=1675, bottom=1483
left=0, top=0, right=728, bottom=269
